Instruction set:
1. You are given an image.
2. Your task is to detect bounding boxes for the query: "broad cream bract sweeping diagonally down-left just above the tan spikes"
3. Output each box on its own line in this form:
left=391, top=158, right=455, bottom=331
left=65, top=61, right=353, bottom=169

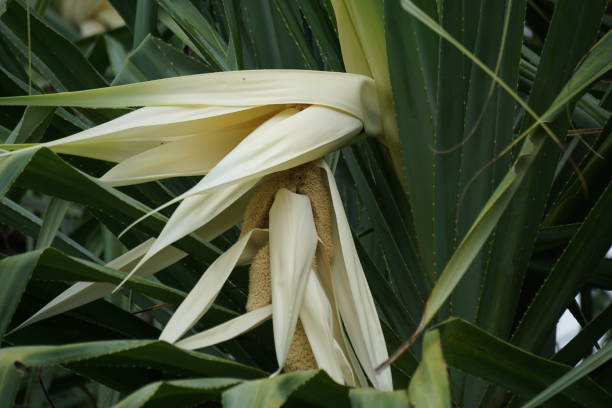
left=123, top=106, right=362, bottom=278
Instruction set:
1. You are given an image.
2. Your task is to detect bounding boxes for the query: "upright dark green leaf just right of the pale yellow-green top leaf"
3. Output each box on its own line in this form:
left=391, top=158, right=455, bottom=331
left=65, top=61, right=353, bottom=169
left=384, top=0, right=439, bottom=281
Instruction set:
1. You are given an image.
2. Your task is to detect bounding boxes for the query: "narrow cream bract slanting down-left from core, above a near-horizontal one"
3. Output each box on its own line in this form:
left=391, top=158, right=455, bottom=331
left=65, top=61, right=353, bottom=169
left=159, top=230, right=268, bottom=343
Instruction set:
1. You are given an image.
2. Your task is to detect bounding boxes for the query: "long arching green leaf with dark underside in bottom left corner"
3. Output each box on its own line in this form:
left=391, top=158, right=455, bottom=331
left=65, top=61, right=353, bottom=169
left=0, top=340, right=265, bottom=408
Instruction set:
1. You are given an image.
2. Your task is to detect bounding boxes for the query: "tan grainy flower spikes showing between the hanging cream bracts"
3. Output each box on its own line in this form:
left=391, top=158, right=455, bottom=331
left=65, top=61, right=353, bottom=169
left=242, top=163, right=333, bottom=371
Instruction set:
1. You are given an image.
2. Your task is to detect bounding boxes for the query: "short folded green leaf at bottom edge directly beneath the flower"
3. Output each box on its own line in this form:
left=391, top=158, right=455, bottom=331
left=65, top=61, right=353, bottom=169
left=223, top=370, right=349, bottom=408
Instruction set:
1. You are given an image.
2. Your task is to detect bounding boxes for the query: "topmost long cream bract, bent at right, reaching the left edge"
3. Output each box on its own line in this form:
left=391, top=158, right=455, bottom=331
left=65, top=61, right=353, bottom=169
left=0, top=70, right=381, bottom=135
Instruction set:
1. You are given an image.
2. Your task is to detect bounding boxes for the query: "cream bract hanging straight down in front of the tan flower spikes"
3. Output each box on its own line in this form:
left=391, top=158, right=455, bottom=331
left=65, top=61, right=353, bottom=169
left=270, top=189, right=318, bottom=369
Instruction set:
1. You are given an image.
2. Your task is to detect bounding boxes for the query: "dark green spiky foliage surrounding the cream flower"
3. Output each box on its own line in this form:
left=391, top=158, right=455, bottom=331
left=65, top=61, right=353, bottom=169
left=0, top=0, right=612, bottom=407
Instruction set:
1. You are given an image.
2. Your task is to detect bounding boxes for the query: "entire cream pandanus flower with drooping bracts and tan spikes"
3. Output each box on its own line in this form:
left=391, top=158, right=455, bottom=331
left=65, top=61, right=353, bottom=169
left=0, top=70, right=392, bottom=390
